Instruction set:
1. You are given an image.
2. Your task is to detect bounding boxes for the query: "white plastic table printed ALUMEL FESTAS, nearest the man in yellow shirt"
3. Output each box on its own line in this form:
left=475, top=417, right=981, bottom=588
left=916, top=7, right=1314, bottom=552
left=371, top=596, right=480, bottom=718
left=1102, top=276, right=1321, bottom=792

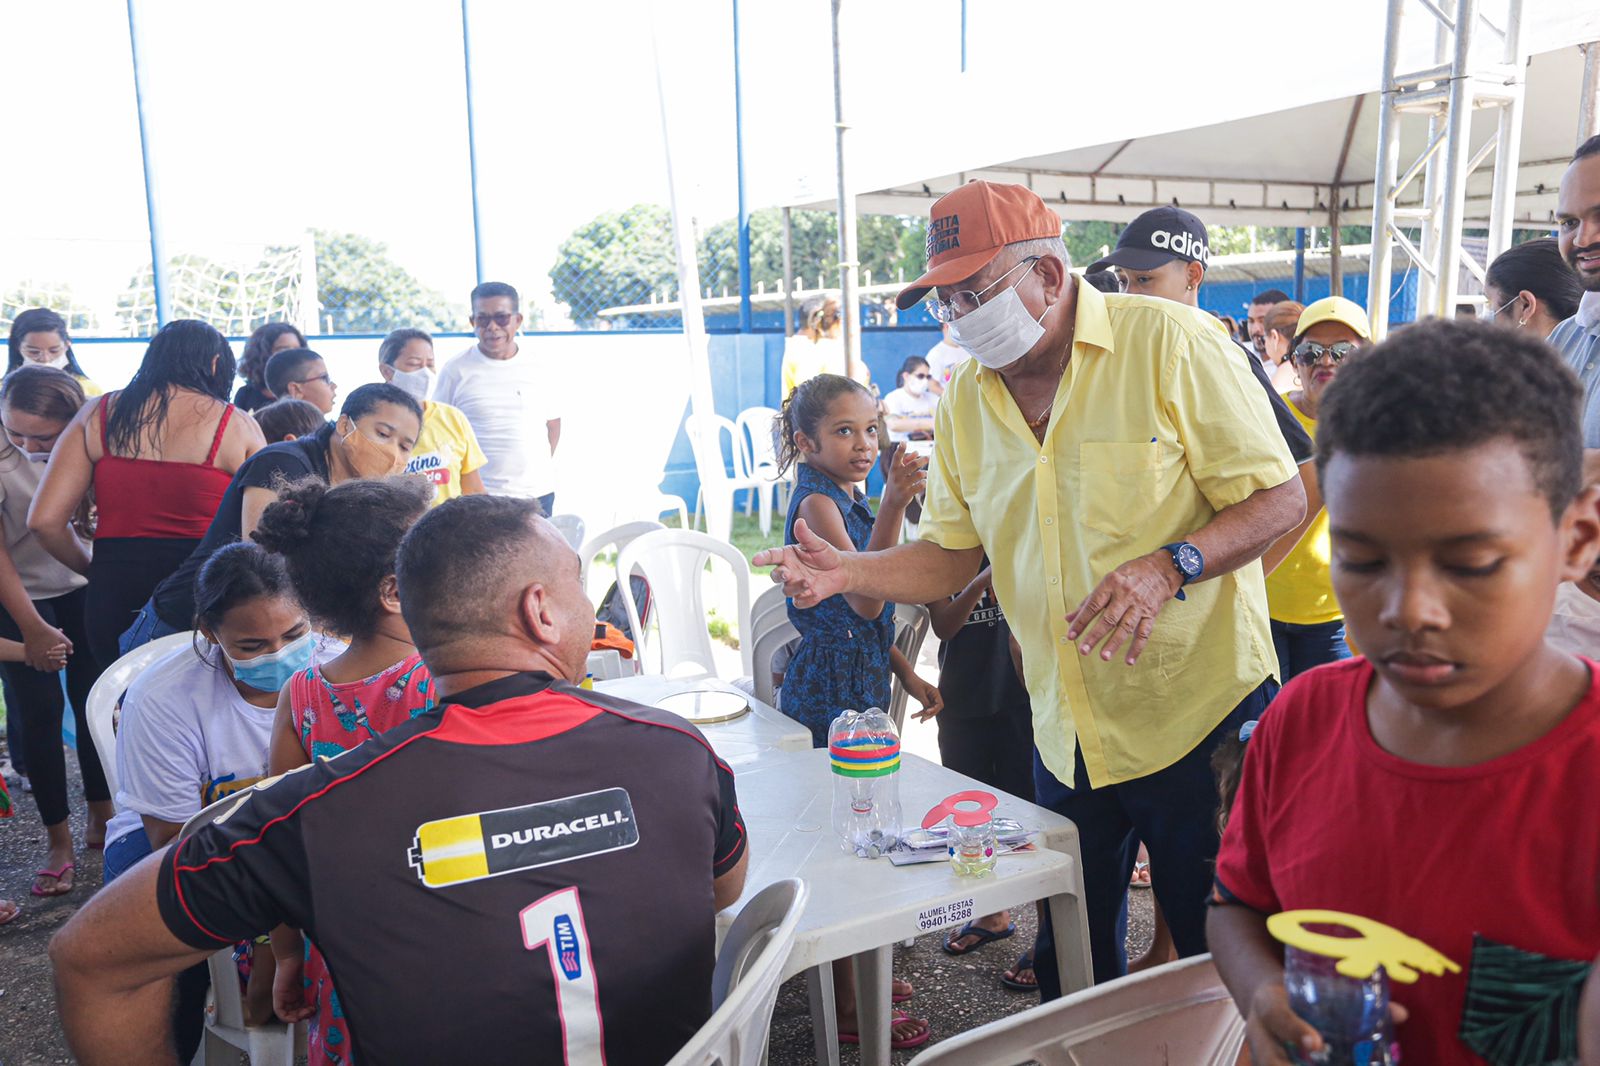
left=720, top=745, right=1093, bottom=1066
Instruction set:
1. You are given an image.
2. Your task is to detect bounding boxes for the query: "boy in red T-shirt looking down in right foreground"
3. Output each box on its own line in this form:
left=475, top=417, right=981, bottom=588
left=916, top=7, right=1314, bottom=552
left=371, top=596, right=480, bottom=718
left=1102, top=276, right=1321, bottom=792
left=1206, top=320, right=1600, bottom=1066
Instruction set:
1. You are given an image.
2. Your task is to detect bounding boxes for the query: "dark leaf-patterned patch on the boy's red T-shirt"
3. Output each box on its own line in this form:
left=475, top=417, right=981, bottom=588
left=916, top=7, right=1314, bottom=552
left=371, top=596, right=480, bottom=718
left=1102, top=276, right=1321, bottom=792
left=1461, top=936, right=1589, bottom=1066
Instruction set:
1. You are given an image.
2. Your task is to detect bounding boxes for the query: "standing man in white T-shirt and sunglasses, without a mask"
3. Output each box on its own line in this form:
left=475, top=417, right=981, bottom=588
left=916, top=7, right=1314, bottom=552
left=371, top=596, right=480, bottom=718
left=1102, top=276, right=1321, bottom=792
left=434, top=282, right=562, bottom=514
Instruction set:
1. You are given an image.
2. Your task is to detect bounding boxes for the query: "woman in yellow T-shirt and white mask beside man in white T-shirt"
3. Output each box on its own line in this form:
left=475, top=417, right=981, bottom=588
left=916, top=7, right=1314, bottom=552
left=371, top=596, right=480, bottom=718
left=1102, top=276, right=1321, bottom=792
left=378, top=330, right=486, bottom=507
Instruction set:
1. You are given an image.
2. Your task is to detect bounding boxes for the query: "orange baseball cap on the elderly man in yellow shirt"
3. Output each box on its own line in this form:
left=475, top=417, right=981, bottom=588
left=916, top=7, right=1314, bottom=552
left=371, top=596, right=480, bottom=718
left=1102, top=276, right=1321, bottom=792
left=894, top=181, right=1061, bottom=311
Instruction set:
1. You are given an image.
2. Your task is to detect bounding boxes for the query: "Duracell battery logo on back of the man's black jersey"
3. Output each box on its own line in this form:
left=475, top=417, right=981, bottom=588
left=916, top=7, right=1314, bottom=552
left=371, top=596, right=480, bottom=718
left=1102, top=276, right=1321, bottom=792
left=406, top=787, right=638, bottom=888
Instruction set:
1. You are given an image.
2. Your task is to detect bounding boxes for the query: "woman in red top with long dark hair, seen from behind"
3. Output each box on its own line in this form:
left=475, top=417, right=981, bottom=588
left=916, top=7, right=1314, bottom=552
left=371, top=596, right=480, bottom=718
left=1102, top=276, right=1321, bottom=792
left=29, top=320, right=266, bottom=664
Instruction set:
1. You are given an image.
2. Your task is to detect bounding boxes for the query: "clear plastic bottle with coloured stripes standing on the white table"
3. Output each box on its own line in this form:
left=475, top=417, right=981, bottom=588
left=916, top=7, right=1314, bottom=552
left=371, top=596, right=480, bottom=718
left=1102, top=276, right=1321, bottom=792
left=827, top=707, right=901, bottom=858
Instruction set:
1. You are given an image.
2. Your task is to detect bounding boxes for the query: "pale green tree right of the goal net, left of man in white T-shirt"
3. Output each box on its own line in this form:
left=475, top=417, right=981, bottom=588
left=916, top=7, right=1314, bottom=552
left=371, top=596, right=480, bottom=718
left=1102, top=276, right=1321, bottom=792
left=308, top=229, right=464, bottom=333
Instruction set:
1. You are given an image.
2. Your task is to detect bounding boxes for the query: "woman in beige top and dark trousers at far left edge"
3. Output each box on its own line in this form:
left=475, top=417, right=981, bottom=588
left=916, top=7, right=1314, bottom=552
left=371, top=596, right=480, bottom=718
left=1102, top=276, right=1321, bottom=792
left=0, top=363, right=100, bottom=896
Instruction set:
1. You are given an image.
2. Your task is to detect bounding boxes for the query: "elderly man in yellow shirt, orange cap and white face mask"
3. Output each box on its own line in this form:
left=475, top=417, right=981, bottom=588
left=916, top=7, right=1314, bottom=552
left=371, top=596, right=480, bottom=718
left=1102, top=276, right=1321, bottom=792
left=755, top=181, right=1306, bottom=1000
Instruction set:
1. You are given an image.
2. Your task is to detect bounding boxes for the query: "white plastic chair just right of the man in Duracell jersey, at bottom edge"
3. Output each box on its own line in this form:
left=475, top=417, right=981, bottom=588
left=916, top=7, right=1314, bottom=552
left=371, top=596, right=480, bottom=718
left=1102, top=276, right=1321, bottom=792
left=667, top=877, right=810, bottom=1066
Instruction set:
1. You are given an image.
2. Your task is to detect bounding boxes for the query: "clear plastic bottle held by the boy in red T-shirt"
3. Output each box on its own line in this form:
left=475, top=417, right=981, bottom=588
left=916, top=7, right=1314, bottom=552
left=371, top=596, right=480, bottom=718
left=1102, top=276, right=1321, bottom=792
left=1283, top=946, right=1400, bottom=1066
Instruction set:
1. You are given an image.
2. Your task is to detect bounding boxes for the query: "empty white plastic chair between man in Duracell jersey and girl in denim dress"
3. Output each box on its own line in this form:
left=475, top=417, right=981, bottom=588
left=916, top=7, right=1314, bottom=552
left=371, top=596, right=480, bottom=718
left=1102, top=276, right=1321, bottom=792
left=616, top=530, right=752, bottom=677
